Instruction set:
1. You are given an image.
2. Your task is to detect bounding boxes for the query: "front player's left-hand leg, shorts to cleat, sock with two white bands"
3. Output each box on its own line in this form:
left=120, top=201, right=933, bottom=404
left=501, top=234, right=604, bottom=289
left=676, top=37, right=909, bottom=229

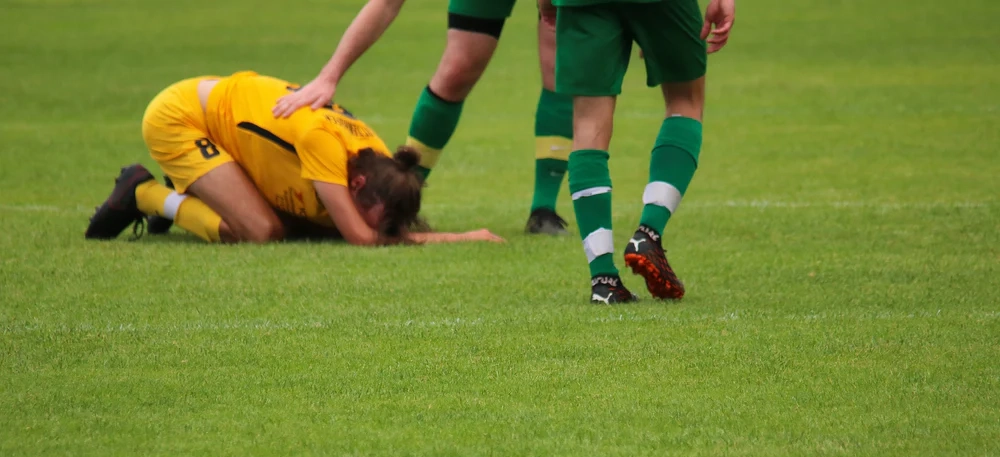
left=556, top=4, right=635, bottom=303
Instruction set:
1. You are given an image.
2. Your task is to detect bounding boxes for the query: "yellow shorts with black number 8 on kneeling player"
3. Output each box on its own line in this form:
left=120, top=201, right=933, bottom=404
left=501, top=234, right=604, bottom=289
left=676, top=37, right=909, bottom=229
left=142, top=76, right=233, bottom=193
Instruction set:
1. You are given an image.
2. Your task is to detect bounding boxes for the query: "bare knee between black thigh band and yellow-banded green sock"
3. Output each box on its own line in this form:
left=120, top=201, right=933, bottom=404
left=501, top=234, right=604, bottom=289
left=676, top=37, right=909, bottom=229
left=430, top=19, right=503, bottom=102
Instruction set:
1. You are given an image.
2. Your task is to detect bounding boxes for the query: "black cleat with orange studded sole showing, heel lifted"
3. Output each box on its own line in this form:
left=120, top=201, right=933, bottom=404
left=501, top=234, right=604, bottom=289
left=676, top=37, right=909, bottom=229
left=625, top=225, right=684, bottom=300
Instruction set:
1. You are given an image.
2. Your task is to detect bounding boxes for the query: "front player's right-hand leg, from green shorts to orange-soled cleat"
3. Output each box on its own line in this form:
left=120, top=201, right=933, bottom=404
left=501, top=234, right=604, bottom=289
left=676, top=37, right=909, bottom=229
left=625, top=0, right=706, bottom=299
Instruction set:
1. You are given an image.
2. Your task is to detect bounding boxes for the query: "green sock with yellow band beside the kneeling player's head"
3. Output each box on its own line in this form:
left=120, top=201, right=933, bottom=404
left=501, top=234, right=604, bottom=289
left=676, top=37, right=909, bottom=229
left=406, top=86, right=464, bottom=179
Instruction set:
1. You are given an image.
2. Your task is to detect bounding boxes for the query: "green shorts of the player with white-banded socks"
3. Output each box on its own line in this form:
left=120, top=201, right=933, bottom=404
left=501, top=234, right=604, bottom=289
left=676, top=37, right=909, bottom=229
left=556, top=0, right=708, bottom=96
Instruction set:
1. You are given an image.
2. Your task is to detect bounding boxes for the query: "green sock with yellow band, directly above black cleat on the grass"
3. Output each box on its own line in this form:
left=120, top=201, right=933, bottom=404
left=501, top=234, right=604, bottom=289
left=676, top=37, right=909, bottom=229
left=531, top=88, right=573, bottom=211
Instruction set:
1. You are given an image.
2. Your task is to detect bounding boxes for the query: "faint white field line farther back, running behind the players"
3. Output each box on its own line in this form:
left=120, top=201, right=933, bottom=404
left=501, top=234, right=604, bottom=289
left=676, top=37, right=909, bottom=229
left=0, top=200, right=997, bottom=214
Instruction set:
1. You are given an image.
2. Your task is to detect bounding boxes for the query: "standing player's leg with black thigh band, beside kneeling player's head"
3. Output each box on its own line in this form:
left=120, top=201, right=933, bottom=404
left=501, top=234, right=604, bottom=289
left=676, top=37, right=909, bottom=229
left=406, top=0, right=514, bottom=178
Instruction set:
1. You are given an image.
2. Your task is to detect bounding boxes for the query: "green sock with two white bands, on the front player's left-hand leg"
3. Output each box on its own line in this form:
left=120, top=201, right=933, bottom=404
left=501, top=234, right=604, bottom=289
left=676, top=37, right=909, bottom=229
left=569, top=149, right=618, bottom=277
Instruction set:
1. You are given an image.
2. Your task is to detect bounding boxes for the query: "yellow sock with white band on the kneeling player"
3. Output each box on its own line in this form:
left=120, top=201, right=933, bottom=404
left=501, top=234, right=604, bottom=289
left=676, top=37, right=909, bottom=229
left=135, top=181, right=222, bottom=243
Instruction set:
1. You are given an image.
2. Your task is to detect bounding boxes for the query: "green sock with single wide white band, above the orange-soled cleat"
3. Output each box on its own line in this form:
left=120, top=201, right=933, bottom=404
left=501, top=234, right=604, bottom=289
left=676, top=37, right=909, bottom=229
left=639, top=116, right=701, bottom=234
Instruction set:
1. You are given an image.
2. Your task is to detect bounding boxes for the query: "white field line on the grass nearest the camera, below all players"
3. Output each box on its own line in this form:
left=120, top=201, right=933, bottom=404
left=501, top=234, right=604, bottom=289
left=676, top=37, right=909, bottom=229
left=0, top=309, right=1000, bottom=335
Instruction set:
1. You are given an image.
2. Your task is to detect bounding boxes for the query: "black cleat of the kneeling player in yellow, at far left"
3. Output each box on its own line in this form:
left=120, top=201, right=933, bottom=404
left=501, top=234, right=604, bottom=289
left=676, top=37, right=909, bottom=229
left=84, top=164, right=154, bottom=240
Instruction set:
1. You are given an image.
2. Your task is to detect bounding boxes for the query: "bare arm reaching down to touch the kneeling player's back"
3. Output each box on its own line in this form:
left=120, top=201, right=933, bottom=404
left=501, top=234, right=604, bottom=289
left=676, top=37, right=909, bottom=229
left=272, top=0, right=405, bottom=118
